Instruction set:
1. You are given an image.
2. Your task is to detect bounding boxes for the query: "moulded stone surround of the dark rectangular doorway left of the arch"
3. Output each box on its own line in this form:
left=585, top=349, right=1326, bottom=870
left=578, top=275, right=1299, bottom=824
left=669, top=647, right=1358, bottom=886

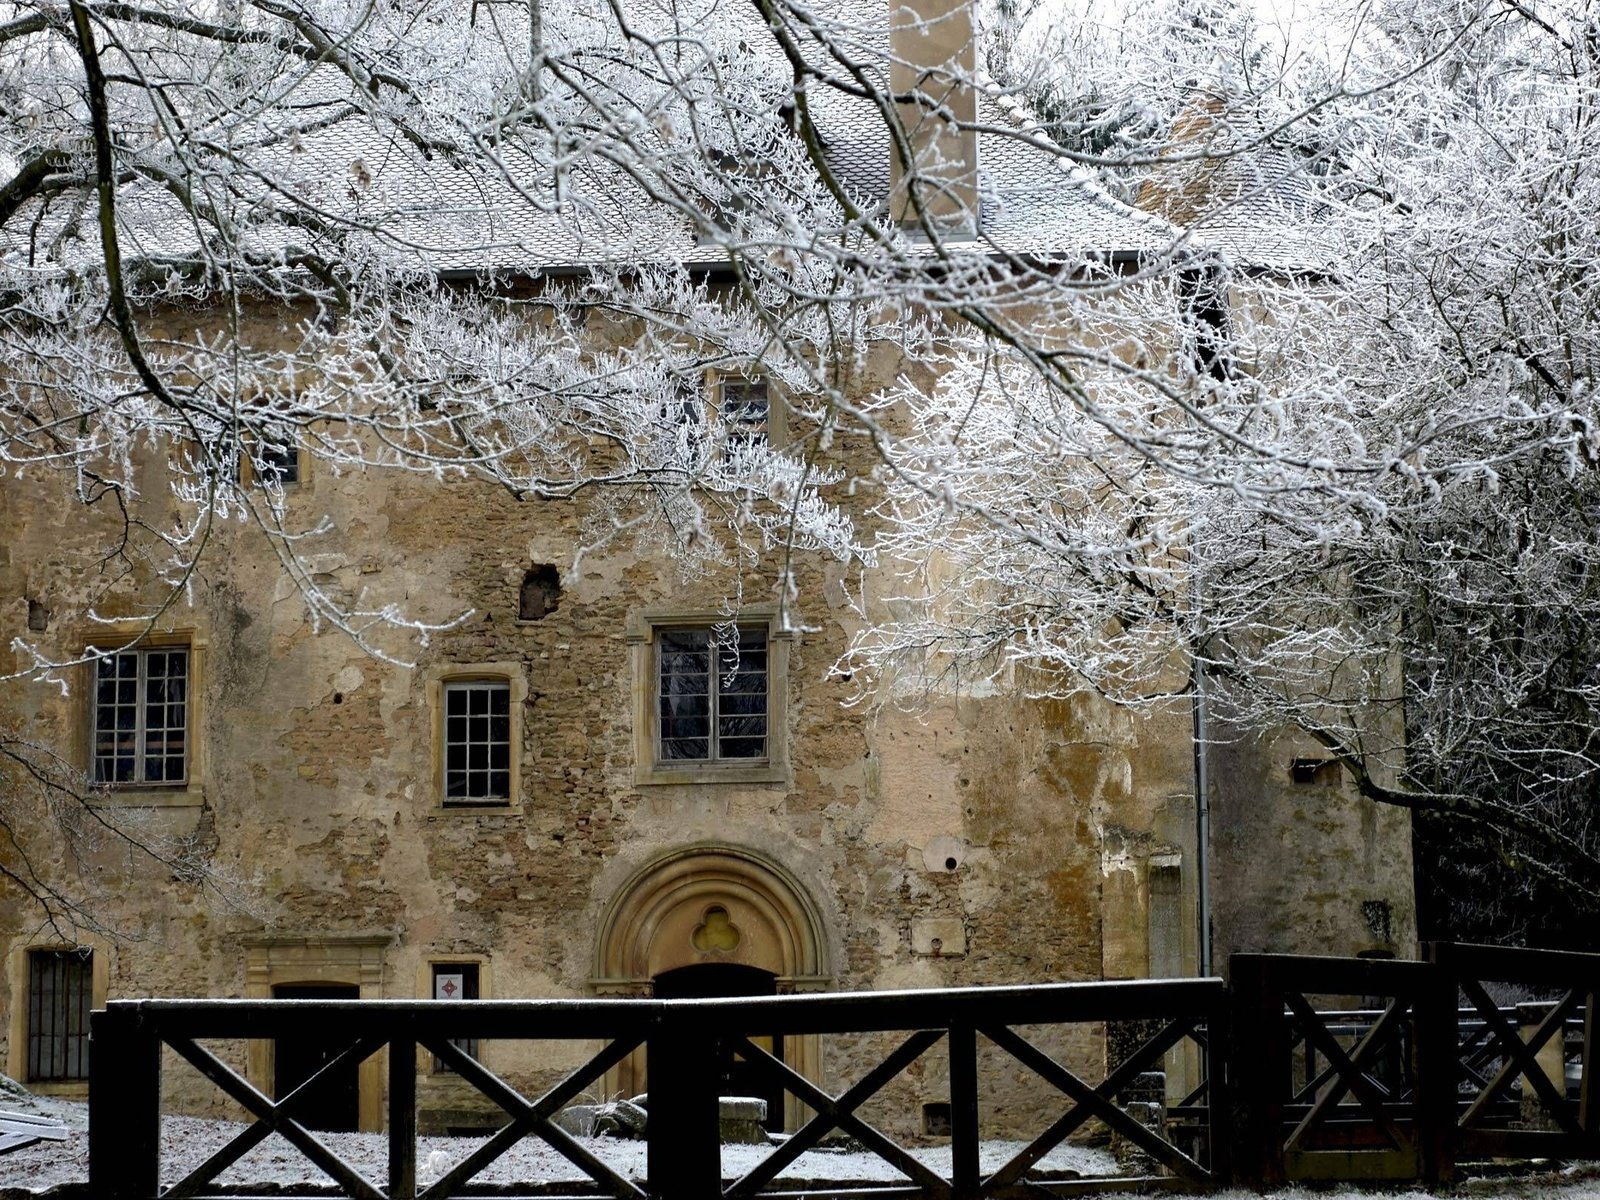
left=240, top=933, right=394, bottom=1133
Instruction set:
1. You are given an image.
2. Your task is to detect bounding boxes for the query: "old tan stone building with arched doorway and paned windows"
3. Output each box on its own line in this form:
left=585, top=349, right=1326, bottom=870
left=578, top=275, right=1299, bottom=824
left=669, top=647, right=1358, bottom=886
left=0, top=0, right=1414, bottom=1130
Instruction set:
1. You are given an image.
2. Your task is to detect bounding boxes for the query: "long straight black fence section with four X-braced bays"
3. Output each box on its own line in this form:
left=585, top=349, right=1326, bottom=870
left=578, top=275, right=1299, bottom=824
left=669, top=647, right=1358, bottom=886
left=90, top=979, right=1227, bottom=1200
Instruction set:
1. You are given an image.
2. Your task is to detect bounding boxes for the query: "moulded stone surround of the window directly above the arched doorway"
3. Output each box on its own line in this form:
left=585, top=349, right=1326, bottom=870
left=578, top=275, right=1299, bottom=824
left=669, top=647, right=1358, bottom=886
left=627, top=605, right=795, bottom=786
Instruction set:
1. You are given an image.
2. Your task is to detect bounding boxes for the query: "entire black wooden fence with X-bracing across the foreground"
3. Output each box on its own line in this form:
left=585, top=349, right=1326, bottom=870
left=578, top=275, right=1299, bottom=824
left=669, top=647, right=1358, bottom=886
left=90, top=944, right=1600, bottom=1200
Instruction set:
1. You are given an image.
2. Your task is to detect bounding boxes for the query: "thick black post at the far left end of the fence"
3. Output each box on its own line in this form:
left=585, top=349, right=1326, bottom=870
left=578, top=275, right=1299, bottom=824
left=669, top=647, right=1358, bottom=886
left=90, top=1002, right=162, bottom=1200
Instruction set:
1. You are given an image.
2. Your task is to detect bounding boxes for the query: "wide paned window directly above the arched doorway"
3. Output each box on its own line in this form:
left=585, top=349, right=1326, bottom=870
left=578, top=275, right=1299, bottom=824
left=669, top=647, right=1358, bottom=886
left=656, top=626, right=768, bottom=763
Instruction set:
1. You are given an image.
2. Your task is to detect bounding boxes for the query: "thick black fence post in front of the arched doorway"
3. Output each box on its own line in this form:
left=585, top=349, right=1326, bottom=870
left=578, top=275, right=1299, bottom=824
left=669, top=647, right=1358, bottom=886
left=645, top=1002, right=722, bottom=1200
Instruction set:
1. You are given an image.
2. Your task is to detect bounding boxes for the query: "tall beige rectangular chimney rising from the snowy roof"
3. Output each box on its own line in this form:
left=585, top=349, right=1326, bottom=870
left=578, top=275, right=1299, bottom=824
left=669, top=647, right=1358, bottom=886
left=890, top=0, right=978, bottom=237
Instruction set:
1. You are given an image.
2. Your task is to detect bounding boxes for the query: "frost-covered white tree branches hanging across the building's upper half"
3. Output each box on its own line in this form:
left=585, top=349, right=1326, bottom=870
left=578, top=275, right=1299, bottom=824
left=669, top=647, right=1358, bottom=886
left=0, top=0, right=1600, bottom=928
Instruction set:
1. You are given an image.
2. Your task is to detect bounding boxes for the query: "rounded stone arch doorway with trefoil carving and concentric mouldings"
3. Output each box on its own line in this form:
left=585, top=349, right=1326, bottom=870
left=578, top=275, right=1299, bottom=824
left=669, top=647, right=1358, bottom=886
left=592, top=845, right=832, bottom=1128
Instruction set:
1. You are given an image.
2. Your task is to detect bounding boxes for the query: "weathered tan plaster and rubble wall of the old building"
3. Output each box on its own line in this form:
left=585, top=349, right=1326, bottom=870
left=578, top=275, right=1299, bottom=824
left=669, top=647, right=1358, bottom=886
left=0, top=296, right=1410, bottom=1130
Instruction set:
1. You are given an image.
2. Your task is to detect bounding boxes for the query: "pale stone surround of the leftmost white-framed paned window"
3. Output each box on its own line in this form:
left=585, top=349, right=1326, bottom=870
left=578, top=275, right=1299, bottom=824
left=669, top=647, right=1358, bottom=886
left=72, top=621, right=210, bottom=808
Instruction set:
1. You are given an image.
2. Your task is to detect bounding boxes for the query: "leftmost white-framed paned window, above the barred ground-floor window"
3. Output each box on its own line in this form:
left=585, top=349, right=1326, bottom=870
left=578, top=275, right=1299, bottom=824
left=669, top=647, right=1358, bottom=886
left=90, top=646, right=189, bottom=786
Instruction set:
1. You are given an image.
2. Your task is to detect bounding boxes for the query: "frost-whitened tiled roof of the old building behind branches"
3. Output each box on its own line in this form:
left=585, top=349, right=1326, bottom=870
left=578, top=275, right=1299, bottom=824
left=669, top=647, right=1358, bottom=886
left=0, top=0, right=1309, bottom=272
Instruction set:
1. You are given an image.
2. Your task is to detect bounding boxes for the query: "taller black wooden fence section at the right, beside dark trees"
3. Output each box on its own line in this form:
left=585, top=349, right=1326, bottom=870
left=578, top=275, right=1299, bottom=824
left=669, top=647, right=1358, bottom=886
left=1227, top=942, right=1600, bottom=1184
